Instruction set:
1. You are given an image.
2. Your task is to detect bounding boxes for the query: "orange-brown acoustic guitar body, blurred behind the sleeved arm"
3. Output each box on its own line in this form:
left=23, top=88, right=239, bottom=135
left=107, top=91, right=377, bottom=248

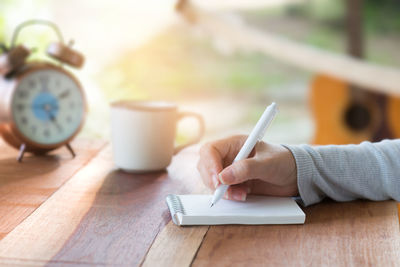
left=310, top=75, right=400, bottom=145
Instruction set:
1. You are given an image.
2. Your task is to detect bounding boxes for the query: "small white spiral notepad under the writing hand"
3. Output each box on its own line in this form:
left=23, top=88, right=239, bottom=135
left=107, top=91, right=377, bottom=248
left=166, top=194, right=306, bottom=225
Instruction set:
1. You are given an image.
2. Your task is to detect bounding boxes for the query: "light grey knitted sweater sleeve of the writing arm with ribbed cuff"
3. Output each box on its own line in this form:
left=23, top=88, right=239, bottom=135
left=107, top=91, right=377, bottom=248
left=285, top=139, right=400, bottom=206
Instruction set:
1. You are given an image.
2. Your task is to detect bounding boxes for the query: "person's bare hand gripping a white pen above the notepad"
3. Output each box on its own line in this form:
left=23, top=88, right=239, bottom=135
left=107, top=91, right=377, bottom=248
left=197, top=135, right=299, bottom=201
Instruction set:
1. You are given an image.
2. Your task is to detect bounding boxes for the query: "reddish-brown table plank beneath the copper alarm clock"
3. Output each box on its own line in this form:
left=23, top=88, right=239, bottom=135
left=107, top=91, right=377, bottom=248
left=0, top=140, right=104, bottom=242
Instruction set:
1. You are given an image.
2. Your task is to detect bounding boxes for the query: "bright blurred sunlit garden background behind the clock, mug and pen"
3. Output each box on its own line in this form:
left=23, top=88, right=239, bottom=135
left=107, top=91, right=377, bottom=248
left=0, top=0, right=400, bottom=144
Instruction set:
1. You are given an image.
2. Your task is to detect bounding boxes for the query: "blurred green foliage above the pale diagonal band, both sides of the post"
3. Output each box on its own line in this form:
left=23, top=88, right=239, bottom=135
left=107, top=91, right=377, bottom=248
left=244, top=0, right=400, bottom=67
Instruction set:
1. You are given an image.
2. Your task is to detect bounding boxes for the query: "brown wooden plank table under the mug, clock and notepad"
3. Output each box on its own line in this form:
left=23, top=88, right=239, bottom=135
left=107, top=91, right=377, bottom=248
left=0, top=140, right=400, bottom=266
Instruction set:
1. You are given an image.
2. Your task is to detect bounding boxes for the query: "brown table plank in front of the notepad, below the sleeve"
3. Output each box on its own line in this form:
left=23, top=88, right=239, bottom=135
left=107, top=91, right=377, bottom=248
left=193, top=201, right=400, bottom=266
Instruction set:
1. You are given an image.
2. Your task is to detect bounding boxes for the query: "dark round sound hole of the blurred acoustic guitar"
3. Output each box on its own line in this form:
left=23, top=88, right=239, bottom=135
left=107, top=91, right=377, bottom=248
left=345, top=104, right=371, bottom=131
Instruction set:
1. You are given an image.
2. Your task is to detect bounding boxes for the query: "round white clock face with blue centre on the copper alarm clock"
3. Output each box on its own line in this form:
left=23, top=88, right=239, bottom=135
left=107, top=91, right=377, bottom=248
left=11, top=69, right=85, bottom=145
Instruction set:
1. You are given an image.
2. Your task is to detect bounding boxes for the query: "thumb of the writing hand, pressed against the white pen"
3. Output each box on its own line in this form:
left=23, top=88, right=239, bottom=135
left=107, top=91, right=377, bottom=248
left=219, top=159, right=255, bottom=185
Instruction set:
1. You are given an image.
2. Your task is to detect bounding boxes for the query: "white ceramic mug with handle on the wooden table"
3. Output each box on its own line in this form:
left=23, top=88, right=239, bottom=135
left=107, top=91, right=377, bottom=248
left=111, top=101, right=204, bottom=172
